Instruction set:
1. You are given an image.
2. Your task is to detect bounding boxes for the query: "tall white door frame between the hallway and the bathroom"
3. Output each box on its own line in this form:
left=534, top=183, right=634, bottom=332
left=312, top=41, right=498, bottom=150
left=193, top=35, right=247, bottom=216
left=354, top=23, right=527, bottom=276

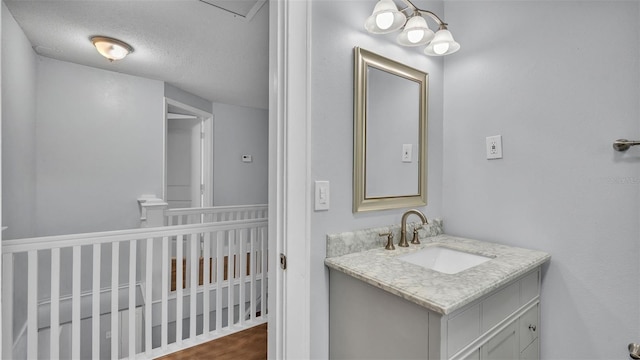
left=268, top=0, right=311, bottom=359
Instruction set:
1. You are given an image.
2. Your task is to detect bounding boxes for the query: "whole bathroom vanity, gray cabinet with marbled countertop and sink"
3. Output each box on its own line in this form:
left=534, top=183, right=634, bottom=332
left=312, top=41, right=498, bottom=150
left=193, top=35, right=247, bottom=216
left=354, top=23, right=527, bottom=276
left=325, top=222, right=550, bottom=360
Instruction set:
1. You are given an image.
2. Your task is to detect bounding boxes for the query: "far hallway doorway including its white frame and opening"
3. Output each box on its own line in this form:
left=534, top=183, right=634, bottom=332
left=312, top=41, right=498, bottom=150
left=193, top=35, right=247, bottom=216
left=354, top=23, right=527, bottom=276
left=162, top=98, right=213, bottom=209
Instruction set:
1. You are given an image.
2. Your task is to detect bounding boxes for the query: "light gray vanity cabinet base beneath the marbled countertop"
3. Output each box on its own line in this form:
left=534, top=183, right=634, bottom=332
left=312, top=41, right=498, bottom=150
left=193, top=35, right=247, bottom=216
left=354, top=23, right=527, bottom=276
left=329, top=266, right=540, bottom=360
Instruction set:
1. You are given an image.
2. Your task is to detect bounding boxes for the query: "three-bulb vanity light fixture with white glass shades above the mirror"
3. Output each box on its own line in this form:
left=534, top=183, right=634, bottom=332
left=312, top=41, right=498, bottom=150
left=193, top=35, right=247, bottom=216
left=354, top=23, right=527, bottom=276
left=364, top=0, right=460, bottom=56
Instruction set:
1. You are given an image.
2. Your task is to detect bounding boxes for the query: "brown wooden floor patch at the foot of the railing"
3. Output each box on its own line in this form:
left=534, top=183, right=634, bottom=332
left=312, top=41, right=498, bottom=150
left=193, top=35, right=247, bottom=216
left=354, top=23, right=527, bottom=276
left=156, top=324, right=267, bottom=360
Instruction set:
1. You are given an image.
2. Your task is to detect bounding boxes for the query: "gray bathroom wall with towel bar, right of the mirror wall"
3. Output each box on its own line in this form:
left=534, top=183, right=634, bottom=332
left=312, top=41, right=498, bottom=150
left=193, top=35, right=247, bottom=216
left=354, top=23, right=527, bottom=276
left=442, top=1, right=640, bottom=359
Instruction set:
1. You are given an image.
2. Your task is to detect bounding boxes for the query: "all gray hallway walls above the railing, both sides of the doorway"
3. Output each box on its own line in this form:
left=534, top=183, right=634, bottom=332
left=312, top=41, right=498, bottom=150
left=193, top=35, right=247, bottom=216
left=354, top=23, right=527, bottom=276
left=2, top=45, right=268, bottom=239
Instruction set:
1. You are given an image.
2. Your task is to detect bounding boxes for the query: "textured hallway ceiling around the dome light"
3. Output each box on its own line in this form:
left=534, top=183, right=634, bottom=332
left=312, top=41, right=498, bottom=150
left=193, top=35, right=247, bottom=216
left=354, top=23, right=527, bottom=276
left=5, top=0, right=269, bottom=109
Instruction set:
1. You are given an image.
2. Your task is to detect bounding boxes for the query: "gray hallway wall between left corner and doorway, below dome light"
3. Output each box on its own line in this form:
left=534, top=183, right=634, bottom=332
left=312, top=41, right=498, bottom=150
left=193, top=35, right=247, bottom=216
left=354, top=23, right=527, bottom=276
left=36, top=57, right=164, bottom=236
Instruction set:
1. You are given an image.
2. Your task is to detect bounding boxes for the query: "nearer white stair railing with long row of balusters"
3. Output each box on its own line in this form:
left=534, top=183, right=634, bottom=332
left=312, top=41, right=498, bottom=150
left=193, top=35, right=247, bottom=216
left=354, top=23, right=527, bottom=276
left=2, top=219, right=268, bottom=359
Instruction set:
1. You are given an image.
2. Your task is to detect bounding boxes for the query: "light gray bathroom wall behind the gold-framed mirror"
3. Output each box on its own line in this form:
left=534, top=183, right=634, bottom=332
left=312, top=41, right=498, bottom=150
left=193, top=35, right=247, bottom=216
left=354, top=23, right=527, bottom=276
left=309, top=0, right=443, bottom=359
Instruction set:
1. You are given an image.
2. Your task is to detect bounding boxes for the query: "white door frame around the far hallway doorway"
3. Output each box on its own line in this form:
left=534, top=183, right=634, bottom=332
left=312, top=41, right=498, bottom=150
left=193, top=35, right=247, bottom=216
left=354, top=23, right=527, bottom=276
left=162, top=97, right=213, bottom=207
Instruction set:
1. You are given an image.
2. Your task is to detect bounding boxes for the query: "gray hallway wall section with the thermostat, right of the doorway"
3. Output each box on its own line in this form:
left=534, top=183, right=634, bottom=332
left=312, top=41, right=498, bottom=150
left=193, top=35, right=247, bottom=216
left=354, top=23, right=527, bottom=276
left=213, top=103, right=269, bottom=206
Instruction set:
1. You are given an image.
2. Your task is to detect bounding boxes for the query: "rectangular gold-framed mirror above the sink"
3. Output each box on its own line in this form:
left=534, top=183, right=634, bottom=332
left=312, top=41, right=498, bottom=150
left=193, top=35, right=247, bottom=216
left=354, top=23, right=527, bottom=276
left=353, top=47, right=429, bottom=213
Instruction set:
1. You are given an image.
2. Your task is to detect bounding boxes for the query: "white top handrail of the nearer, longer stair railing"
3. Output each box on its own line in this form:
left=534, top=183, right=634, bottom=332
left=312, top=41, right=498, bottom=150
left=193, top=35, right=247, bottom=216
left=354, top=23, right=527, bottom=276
left=2, top=219, right=267, bottom=254
